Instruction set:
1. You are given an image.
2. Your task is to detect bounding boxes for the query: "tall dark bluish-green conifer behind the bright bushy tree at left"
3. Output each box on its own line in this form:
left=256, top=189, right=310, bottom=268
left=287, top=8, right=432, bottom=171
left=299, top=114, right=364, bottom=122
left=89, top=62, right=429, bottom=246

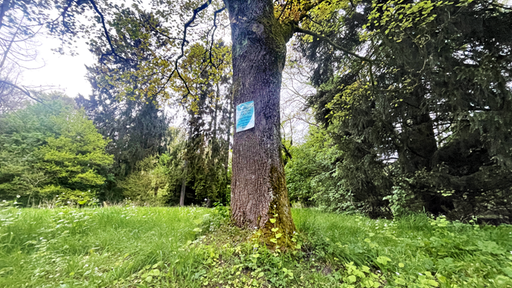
left=77, top=7, right=174, bottom=201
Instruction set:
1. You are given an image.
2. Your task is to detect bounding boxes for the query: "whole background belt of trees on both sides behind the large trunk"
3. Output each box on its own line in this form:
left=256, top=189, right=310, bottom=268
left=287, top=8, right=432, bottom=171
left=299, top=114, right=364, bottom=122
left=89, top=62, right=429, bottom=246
left=0, top=0, right=512, bottom=223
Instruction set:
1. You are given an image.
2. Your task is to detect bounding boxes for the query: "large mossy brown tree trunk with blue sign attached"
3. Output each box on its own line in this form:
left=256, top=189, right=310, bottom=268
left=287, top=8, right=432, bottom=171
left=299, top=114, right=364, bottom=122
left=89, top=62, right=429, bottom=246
left=225, top=0, right=295, bottom=246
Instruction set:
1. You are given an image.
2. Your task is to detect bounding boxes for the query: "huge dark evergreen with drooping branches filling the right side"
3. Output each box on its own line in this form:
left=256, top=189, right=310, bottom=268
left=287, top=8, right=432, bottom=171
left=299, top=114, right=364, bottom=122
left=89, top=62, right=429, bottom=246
left=304, top=1, right=512, bottom=219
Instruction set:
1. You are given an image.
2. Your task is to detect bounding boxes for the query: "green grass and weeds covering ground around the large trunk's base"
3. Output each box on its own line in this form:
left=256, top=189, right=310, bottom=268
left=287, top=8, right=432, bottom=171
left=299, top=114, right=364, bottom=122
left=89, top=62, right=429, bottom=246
left=0, top=207, right=512, bottom=288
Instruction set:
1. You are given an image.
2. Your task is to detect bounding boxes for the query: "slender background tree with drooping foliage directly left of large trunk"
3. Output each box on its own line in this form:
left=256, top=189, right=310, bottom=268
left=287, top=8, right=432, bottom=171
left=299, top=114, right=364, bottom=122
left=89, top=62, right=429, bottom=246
left=173, top=42, right=233, bottom=206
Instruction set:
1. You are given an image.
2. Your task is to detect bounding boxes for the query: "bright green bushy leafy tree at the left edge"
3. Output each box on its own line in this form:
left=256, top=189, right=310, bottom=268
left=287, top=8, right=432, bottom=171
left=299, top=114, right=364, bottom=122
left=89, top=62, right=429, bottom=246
left=0, top=94, right=112, bottom=205
